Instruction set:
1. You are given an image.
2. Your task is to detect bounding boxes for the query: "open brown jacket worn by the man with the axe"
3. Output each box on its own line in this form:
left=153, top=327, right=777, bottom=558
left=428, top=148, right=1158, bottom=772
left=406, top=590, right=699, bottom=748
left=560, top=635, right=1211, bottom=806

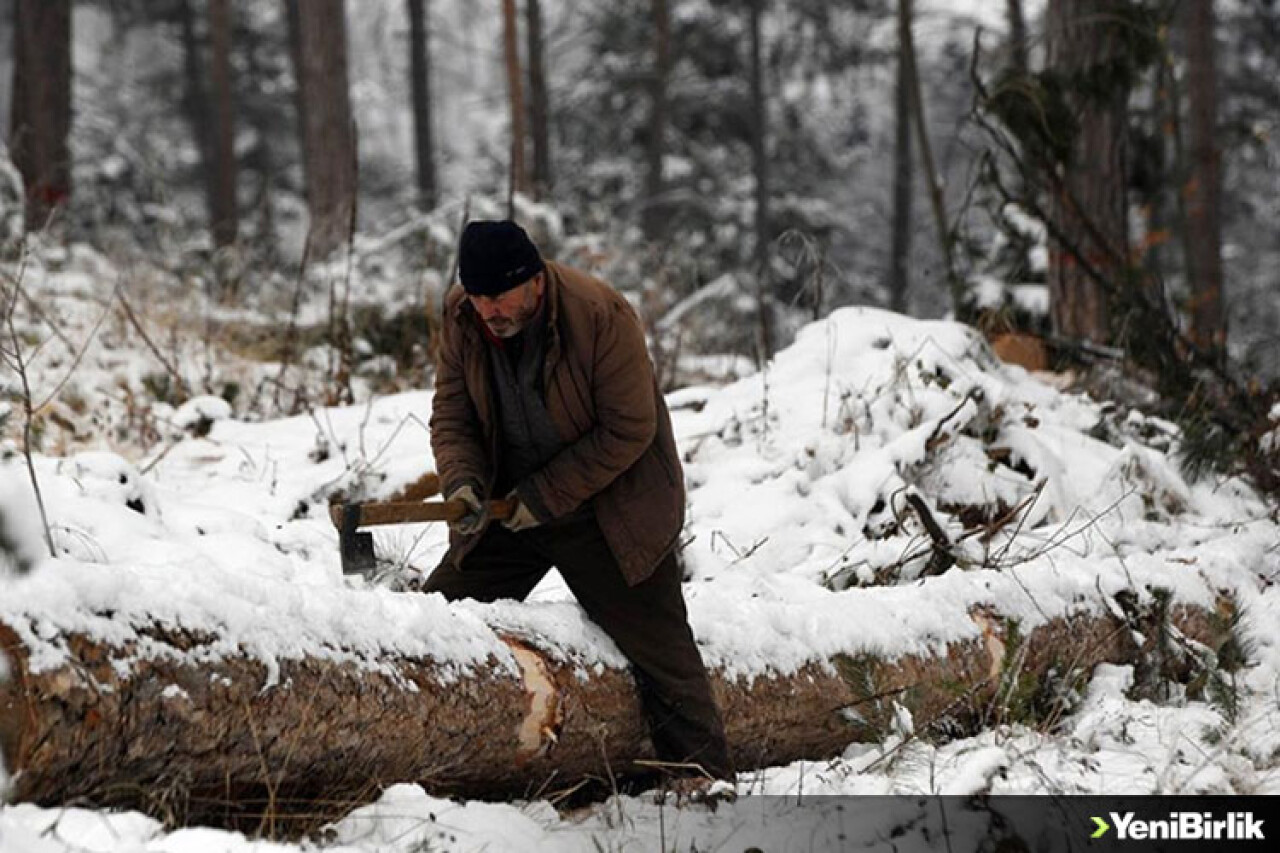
left=430, top=261, right=685, bottom=584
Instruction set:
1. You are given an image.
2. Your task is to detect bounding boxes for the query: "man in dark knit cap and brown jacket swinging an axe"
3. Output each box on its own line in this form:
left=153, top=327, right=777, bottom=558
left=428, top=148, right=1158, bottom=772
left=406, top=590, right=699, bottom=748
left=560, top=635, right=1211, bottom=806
left=424, top=216, right=732, bottom=779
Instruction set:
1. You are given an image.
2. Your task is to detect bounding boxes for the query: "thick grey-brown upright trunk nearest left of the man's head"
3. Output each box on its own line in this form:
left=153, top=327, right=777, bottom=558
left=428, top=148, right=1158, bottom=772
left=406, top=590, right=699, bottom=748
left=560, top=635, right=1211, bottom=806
left=288, top=0, right=356, bottom=260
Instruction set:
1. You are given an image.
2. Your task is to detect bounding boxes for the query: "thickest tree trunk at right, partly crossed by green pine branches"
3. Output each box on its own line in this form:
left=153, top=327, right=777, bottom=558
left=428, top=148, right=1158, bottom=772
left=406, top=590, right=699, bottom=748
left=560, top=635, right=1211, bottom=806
left=1048, top=0, right=1128, bottom=343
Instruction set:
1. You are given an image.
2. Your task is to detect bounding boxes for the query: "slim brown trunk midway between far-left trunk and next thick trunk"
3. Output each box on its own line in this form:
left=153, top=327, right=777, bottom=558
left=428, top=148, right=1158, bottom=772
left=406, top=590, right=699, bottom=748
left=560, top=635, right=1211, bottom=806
left=207, top=0, right=239, bottom=248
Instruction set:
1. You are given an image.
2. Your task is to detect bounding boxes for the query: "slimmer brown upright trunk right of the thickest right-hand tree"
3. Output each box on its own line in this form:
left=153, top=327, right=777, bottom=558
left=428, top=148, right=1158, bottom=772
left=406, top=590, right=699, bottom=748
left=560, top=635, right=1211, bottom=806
left=1183, top=0, right=1226, bottom=356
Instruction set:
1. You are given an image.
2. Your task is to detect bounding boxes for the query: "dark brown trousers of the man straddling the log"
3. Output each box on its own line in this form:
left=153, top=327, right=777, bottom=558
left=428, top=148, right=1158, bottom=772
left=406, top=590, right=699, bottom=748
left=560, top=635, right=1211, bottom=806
left=422, top=515, right=733, bottom=779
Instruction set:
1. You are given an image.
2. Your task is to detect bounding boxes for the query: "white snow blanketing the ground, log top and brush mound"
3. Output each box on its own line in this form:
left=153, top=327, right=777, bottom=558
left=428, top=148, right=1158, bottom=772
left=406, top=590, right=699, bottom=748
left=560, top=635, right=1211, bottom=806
left=0, top=280, right=1280, bottom=853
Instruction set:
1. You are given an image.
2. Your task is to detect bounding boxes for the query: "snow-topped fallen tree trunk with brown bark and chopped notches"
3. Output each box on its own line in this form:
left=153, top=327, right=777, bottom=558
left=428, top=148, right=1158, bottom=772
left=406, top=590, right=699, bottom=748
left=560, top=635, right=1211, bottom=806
left=0, top=594, right=1219, bottom=826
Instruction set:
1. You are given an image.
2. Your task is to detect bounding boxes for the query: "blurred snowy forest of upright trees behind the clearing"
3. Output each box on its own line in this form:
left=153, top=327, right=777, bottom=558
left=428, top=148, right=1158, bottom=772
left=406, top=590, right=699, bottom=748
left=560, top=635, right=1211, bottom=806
left=0, top=0, right=1280, bottom=409
